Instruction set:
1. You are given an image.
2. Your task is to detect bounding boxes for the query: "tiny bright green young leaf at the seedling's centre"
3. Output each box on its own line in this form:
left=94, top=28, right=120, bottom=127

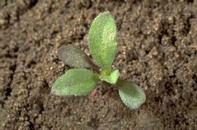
left=99, top=70, right=120, bottom=84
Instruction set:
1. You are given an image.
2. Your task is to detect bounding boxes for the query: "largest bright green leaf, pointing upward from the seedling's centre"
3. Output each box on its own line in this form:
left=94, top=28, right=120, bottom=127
left=88, top=12, right=117, bottom=71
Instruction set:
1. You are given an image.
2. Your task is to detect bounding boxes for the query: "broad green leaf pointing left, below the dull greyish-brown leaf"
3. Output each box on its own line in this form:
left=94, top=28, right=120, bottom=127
left=51, top=69, right=98, bottom=96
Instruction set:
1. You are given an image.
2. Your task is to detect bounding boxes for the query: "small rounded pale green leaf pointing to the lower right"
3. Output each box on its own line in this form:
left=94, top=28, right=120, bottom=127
left=117, top=81, right=146, bottom=109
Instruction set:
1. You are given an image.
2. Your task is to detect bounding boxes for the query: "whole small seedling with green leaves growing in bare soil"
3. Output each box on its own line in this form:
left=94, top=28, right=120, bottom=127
left=51, top=12, right=146, bottom=109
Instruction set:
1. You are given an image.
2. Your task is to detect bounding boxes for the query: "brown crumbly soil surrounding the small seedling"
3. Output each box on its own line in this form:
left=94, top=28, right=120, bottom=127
left=0, top=0, right=197, bottom=130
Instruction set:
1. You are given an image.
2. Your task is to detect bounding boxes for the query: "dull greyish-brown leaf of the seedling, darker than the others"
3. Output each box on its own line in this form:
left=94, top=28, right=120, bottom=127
left=58, top=45, right=91, bottom=68
